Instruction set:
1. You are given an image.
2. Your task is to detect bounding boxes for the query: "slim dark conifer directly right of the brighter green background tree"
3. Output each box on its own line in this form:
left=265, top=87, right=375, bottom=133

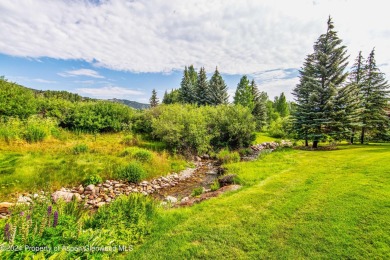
left=250, top=79, right=268, bottom=131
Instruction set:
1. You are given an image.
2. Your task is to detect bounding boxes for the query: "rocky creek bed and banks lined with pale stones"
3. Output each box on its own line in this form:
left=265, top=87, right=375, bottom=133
left=0, top=141, right=291, bottom=218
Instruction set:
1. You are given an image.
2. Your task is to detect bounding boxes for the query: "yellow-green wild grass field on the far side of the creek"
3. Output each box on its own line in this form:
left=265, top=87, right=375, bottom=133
left=0, top=132, right=186, bottom=201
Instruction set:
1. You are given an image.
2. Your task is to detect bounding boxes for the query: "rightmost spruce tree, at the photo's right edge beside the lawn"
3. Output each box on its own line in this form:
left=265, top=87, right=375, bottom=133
left=360, top=49, right=389, bottom=144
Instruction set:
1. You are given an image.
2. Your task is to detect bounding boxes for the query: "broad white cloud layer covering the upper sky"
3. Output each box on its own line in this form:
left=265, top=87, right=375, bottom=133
left=0, top=0, right=390, bottom=97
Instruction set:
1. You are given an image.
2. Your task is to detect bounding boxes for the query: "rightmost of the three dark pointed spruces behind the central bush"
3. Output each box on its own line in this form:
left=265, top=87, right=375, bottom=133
left=208, top=68, right=229, bottom=106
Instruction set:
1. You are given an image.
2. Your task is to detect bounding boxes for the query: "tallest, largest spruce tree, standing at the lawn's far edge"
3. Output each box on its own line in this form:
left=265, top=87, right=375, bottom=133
left=295, top=17, right=348, bottom=148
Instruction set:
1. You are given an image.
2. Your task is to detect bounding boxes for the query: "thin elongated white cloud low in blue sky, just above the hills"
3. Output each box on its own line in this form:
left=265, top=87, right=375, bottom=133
left=76, top=86, right=144, bottom=100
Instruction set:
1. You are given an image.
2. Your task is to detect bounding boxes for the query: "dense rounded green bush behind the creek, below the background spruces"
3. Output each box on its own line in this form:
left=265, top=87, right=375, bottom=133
left=151, top=104, right=255, bottom=154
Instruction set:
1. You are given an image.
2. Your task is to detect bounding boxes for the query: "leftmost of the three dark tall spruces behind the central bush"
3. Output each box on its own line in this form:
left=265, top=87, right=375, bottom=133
left=180, top=65, right=197, bottom=104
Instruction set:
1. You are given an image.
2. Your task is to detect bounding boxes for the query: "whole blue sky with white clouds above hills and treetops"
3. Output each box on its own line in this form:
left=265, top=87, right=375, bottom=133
left=0, top=0, right=390, bottom=103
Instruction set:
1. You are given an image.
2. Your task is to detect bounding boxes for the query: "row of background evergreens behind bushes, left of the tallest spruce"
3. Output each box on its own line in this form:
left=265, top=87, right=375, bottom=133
left=149, top=65, right=292, bottom=131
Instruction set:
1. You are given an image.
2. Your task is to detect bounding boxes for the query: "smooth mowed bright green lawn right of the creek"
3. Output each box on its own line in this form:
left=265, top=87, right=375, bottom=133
left=127, top=144, right=390, bottom=259
